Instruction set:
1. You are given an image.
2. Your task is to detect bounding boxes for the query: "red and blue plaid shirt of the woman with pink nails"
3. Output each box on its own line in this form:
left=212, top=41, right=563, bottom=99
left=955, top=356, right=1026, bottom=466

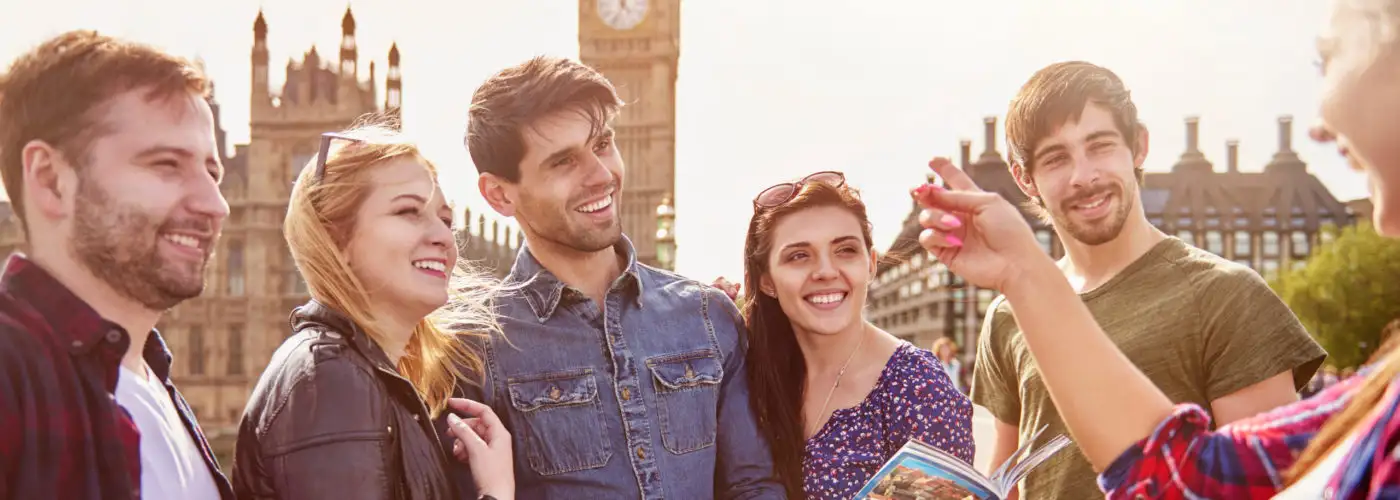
left=1099, top=366, right=1400, bottom=500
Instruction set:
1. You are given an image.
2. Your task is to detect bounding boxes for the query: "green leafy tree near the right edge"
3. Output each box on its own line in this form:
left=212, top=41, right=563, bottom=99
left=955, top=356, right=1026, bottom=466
left=1270, top=223, right=1400, bottom=368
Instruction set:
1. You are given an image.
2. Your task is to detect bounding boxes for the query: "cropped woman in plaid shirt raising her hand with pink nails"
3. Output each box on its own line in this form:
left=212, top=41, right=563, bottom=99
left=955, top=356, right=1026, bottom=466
left=914, top=0, right=1400, bottom=499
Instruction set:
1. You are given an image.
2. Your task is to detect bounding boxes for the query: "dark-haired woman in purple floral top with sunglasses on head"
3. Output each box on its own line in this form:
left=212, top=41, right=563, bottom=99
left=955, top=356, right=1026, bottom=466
left=721, top=172, right=973, bottom=500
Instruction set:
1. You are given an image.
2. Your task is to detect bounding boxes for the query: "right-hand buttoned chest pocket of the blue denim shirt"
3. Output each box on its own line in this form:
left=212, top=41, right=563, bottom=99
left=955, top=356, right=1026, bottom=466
left=647, top=349, right=724, bottom=455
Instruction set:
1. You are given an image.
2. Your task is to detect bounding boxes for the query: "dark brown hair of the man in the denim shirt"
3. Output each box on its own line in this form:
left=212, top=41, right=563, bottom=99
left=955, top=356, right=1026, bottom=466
left=466, top=56, right=622, bottom=182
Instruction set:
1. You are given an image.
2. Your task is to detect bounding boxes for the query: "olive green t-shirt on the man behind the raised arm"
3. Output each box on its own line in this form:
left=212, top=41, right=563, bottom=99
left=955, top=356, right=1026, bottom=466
left=972, top=237, right=1327, bottom=500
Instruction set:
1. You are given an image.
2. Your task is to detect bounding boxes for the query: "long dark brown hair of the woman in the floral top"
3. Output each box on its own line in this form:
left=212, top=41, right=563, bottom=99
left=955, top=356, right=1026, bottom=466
left=743, top=177, right=874, bottom=499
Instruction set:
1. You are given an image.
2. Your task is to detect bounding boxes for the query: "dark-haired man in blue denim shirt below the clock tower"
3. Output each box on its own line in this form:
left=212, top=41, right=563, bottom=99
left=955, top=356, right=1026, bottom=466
left=442, top=57, right=784, bottom=499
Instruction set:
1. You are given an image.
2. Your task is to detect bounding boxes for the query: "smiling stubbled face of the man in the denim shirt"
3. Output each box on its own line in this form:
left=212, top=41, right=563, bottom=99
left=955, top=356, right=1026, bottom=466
left=503, top=109, right=623, bottom=252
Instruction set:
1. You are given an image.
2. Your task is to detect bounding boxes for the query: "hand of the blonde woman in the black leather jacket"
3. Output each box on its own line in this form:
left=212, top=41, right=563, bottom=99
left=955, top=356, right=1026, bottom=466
left=447, top=398, right=515, bottom=500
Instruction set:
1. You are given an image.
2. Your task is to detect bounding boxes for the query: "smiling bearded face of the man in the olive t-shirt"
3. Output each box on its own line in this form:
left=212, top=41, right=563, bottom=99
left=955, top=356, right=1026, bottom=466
left=1016, top=102, right=1147, bottom=245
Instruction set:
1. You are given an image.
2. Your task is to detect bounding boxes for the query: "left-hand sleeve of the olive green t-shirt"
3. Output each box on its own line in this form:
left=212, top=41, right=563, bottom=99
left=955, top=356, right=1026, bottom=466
left=972, top=297, right=1021, bottom=424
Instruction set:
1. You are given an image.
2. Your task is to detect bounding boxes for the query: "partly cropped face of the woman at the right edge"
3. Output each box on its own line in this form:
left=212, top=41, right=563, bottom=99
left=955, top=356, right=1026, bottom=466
left=1315, top=0, right=1400, bottom=237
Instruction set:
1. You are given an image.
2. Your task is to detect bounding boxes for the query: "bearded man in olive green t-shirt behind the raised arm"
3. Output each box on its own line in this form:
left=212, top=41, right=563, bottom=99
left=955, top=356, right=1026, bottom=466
left=972, top=62, right=1326, bottom=500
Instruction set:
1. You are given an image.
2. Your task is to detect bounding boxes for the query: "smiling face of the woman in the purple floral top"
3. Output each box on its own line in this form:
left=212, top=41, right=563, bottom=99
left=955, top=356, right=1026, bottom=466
left=762, top=206, right=875, bottom=335
